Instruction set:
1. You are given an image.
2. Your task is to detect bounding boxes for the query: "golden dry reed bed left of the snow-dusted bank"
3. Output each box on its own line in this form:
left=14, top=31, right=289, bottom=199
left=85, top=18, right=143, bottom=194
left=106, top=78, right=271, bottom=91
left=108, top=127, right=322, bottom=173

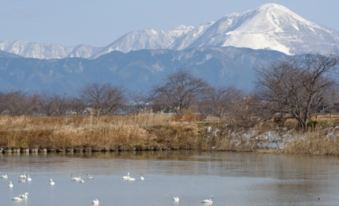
left=0, top=113, right=215, bottom=150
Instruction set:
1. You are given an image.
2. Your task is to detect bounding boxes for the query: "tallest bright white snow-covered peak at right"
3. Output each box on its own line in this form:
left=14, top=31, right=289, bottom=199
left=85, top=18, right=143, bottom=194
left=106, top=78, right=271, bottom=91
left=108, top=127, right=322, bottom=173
left=202, top=4, right=339, bottom=54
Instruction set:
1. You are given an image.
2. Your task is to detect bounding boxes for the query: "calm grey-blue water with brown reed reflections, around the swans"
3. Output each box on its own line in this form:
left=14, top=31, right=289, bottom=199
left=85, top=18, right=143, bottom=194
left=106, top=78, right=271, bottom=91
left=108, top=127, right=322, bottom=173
left=0, top=153, right=339, bottom=206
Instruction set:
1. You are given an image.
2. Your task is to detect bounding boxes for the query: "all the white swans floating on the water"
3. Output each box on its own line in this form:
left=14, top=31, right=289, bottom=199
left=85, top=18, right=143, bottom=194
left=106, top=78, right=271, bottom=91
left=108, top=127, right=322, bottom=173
left=0, top=172, right=213, bottom=206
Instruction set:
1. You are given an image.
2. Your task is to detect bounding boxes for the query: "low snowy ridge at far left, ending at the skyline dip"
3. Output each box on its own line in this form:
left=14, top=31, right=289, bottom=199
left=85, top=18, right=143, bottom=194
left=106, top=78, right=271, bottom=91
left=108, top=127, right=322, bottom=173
left=0, top=41, right=99, bottom=59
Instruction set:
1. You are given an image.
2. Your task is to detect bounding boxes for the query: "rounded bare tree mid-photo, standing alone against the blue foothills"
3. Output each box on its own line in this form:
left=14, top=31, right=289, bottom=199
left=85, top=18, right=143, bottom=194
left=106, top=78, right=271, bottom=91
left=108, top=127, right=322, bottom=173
left=151, top=71, right=210, bottom=112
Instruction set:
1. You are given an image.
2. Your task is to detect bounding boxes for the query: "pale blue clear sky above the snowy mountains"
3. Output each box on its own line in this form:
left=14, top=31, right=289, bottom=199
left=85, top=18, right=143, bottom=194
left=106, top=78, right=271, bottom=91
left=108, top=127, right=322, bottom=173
left=0, top=0, right=339, bottom=46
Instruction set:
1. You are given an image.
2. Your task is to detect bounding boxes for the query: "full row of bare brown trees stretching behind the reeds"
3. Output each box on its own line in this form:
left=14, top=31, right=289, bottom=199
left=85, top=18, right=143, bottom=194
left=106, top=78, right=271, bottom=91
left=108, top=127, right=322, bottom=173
left=0, top=55, right=338, bottom=131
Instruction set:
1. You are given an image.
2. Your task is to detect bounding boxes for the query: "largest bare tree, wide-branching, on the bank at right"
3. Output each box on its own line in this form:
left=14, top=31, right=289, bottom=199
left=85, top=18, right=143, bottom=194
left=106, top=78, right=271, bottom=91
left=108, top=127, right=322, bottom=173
left=258, top=55, right=336, bottom=131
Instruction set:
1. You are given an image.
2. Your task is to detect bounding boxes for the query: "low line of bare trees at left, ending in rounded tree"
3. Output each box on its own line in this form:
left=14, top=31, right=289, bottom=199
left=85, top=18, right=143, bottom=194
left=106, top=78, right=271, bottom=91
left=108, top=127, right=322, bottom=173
left=0, top=84, right=127, bottom=116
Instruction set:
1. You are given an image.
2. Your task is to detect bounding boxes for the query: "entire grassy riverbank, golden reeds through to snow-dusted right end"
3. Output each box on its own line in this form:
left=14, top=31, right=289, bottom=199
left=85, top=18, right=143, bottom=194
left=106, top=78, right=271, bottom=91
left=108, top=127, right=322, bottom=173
left=0, top=113, right=339, bottom=155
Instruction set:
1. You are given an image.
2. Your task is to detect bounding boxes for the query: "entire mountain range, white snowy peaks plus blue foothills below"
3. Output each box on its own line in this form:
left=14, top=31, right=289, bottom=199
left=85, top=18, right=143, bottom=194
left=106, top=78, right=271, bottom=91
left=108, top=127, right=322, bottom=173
left=0, top=4, right=339, bottom=95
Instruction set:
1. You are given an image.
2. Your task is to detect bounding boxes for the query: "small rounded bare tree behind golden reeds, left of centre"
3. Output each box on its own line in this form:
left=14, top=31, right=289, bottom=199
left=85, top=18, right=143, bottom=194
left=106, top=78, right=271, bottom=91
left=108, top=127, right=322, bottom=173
left=81, top=84, right=125, bottom=115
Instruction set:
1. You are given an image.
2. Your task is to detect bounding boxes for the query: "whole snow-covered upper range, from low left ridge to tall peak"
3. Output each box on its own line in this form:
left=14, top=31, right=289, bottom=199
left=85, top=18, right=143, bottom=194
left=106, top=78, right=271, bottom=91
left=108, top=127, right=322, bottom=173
left=0, top=3, right=339, bottom=59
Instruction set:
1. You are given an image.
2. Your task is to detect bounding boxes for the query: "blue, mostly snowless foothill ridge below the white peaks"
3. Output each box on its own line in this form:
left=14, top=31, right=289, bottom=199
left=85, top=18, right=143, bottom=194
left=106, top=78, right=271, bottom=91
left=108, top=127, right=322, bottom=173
left=0, top=47, right=286, bottom=95
